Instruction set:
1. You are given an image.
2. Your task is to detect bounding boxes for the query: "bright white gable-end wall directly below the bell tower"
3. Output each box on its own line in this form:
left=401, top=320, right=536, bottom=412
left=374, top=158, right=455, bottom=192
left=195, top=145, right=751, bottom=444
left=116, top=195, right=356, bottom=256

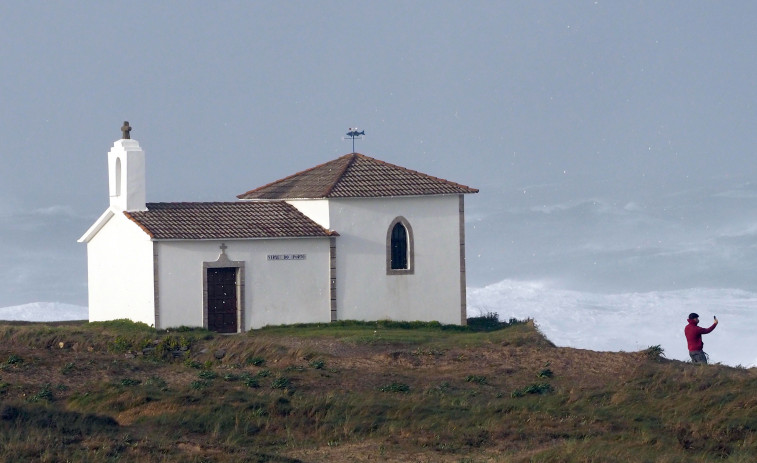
left=87, top=211, right=155, bottom=325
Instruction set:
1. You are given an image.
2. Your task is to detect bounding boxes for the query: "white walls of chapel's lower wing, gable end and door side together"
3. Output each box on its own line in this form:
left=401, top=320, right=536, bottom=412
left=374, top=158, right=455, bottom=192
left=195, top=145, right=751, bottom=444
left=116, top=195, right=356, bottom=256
left=82, top=215, right=331, bottom=331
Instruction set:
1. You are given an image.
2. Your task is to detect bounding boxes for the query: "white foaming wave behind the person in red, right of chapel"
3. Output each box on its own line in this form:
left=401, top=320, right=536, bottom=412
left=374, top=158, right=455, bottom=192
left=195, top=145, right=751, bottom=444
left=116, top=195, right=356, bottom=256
left=468, top=280, right=757, bottom=367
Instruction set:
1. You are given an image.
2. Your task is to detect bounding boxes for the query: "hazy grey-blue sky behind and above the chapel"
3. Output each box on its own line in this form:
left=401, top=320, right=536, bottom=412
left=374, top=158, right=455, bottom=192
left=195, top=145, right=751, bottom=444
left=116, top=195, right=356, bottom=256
left=0, top=0, right=757, bottom=306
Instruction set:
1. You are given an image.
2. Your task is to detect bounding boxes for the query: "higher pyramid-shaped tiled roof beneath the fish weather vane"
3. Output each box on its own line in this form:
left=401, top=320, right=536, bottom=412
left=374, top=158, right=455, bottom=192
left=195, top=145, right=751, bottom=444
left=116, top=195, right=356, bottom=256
left=237, top=153, right=478, bottom=199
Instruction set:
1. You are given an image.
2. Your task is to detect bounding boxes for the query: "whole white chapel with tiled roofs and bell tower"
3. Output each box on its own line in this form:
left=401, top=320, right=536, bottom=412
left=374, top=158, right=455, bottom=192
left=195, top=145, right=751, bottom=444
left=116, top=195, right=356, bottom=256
left=79, top=122, right=478, bottom=333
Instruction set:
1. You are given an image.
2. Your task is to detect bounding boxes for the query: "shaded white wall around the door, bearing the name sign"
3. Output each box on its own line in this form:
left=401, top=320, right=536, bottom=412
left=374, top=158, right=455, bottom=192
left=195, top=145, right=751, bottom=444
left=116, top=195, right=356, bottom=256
left=156, top=238, right=331, bottom=331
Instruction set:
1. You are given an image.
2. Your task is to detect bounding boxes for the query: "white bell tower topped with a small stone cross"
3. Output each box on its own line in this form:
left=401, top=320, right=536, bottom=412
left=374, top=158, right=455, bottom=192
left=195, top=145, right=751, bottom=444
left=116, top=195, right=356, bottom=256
left=108, top=121, right=147, bottom=211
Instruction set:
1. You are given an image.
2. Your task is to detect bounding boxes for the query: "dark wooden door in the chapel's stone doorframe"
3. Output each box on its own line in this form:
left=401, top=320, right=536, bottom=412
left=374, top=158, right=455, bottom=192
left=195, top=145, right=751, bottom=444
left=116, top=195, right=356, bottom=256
left=208, top=267, right=237, bottom=333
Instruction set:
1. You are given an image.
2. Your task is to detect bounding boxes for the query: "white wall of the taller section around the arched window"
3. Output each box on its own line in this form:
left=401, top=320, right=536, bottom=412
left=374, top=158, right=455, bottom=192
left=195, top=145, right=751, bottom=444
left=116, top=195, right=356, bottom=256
left=329, top=195, right=461, bottom=324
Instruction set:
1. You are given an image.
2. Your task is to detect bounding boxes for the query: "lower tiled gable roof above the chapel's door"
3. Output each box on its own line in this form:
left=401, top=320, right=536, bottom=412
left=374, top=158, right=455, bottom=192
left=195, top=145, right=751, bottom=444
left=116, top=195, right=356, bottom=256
left=124, top=201, right=336, bottom=239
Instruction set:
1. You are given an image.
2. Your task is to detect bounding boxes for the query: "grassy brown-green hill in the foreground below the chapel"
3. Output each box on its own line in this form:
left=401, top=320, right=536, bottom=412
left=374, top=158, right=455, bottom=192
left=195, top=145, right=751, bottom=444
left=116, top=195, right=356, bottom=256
left=0, top=321, right=757, bottom=463
